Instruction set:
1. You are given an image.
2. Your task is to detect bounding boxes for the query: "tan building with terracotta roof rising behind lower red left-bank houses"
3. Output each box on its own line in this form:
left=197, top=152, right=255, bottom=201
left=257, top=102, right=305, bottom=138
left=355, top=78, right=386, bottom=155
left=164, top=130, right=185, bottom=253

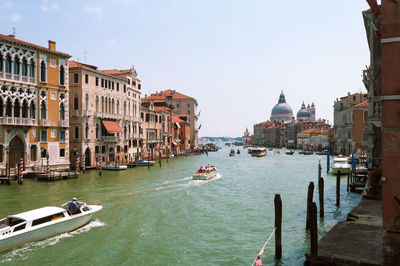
left=144, top=90, right=199, bottom=148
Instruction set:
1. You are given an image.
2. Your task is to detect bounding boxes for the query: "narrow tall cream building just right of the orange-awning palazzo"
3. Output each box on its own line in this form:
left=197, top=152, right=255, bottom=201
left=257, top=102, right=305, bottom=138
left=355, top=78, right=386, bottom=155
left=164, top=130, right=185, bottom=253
left=101, top=67, right=143, bottom=161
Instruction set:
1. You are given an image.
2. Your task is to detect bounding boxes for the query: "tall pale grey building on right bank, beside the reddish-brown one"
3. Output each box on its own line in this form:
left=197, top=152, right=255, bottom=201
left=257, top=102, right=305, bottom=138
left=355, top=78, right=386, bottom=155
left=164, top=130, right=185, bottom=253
left=333, top=92, right=368, bottom=155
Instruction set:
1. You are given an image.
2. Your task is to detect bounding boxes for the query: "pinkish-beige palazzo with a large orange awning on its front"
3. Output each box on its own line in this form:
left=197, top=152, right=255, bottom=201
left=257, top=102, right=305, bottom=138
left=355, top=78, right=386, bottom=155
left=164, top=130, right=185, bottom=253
left=69, top=61, right=135, bottom=167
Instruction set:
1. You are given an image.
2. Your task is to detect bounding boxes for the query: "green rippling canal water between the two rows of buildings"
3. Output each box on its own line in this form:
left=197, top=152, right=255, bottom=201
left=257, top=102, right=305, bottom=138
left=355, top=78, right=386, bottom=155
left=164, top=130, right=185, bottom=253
left=0, top=147, right=361, bottom=265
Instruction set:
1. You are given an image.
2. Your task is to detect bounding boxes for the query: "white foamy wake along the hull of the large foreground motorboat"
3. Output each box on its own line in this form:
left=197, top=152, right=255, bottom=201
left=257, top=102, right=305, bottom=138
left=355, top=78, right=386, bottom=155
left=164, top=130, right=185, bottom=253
left=0, top=219, right=105, bottom=264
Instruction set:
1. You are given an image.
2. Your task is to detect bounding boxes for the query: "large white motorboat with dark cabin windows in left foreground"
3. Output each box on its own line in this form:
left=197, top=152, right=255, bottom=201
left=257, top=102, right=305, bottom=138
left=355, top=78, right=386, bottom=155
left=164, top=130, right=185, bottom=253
left=0, top=202, right=103, bottom=252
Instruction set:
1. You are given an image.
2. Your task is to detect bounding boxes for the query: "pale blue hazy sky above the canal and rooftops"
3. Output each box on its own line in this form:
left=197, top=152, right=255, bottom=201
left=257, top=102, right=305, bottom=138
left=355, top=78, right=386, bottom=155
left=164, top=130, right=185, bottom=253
left=0, top=0, right=369, bottom=136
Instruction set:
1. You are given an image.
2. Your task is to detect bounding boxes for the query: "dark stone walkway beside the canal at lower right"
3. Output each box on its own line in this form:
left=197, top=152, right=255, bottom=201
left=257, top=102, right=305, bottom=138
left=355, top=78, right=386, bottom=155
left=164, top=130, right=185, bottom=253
left=306, top=199, right=383, bottom=266
